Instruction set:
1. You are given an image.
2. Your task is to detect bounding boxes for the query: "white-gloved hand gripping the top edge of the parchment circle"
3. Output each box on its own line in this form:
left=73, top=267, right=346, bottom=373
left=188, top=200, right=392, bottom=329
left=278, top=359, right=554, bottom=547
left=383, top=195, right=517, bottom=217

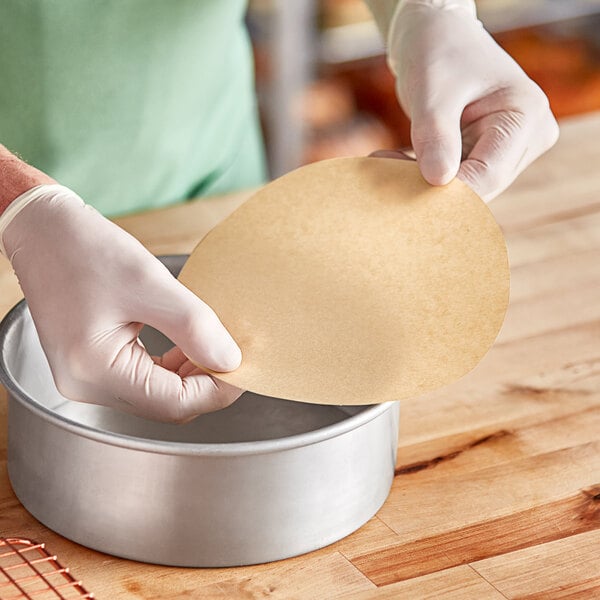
left=369, top=0, right=558, bottom=200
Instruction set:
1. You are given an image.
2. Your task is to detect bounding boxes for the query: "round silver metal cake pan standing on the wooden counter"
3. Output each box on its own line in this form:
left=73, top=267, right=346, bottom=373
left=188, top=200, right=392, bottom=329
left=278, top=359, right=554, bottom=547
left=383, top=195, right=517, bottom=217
left=0, top=256, right=399, bottom=567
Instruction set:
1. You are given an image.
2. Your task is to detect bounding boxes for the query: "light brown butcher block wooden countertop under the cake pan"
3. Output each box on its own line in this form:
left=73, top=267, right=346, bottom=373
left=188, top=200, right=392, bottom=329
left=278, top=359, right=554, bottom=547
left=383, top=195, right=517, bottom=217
left=0, top=113, right=600, bottom=600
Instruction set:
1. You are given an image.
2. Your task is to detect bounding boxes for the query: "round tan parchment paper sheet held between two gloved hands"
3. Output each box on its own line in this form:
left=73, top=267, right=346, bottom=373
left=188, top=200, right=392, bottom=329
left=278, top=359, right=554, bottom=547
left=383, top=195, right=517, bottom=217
left=179, top=157, right=509, bottom=404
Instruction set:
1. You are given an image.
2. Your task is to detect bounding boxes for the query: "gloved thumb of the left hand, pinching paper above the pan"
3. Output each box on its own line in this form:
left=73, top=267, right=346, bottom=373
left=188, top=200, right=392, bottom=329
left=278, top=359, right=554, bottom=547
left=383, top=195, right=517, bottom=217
left=134, top=272, right=242, bottom=371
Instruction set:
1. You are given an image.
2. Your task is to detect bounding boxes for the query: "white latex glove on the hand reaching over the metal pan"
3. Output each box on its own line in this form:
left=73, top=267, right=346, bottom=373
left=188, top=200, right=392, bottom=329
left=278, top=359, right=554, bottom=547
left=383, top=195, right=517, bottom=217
left=0, top=185, right=241, bottom=422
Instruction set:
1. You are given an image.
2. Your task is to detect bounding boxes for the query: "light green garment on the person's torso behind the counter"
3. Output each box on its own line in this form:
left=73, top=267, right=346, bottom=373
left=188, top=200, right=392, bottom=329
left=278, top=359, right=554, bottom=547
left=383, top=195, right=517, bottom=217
left=0, top=0, right=264, bottom=215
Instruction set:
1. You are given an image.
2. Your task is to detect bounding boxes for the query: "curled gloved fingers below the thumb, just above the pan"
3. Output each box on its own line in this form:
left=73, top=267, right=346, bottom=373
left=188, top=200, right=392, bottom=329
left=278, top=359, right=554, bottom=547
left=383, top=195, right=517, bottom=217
left=106, top=340, right=242, bottom=423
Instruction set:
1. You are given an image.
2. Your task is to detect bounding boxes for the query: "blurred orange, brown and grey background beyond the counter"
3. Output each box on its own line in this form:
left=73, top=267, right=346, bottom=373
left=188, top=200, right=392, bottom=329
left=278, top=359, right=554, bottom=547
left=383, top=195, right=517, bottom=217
left=247, top=0, right=600, bottom=177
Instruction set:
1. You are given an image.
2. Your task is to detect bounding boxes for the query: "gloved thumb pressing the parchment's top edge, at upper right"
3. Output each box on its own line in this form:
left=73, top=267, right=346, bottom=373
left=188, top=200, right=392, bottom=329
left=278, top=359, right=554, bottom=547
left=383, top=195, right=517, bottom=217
left=411, top=99, right=463, bottom=185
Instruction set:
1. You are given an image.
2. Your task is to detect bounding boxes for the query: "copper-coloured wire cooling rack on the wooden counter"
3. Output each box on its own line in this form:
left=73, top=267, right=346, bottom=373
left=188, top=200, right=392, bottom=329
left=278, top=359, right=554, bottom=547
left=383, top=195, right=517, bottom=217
left=0, top=537, right=94, bottom=600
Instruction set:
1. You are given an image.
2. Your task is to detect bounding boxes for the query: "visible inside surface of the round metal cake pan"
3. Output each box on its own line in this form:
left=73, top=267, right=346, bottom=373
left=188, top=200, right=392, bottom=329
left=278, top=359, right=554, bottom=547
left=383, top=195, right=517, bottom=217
left=4, top=305, right=369, bottom=444
